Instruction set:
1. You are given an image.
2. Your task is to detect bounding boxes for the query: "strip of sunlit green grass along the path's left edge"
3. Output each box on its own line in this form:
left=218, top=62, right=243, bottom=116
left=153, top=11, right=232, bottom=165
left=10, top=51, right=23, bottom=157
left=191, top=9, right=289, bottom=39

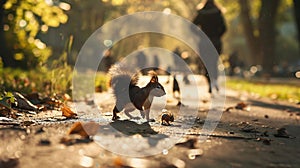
left=0, top=47, right=72, bottom=95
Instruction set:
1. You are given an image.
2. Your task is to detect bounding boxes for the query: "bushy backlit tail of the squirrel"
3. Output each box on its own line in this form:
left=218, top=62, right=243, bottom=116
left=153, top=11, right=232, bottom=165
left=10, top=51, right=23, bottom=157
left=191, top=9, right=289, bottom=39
left=108, top=63, right=139, bottom=99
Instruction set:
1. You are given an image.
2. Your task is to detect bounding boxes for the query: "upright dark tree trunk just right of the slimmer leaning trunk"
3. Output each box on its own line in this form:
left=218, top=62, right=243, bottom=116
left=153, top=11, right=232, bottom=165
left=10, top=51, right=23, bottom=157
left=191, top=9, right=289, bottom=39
left=258, top=0, right=280, bottom=73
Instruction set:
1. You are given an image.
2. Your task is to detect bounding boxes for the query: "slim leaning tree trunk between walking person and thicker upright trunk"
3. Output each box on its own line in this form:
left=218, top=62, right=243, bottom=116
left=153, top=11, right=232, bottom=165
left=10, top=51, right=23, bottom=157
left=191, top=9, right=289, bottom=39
left=239, top=0, right=262, bottom=64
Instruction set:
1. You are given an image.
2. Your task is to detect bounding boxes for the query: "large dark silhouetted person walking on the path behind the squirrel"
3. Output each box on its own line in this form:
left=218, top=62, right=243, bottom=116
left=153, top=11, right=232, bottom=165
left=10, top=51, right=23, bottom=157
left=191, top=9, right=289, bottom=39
left=193, top=0, right=226, bottom=93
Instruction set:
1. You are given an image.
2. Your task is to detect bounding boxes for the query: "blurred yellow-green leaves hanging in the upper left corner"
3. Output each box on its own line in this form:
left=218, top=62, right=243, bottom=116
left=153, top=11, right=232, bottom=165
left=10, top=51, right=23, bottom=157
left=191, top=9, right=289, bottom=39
left=4, top=0, right=68, bottom=68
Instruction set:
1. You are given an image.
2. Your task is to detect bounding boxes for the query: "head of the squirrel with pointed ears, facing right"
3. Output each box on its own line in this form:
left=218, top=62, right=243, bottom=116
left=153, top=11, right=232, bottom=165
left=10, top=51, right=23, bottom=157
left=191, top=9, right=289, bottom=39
left=147, top=75, right=166, bottom=97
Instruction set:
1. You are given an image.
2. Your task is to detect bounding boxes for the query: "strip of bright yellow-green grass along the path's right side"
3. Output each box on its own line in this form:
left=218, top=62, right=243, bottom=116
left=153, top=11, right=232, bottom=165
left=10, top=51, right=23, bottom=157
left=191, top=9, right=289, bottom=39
left=226, top=79, right=300, bottom=103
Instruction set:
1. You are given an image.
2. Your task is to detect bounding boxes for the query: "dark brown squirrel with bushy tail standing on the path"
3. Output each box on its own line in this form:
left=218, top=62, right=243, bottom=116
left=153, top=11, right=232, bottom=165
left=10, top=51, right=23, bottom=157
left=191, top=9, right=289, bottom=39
left=108, top=64, right=166, bottom=121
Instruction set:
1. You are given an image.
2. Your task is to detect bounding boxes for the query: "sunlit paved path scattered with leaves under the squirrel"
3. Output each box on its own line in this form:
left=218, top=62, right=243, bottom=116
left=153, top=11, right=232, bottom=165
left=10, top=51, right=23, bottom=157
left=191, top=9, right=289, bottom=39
left=0, top=77, right=300, bottom=168
